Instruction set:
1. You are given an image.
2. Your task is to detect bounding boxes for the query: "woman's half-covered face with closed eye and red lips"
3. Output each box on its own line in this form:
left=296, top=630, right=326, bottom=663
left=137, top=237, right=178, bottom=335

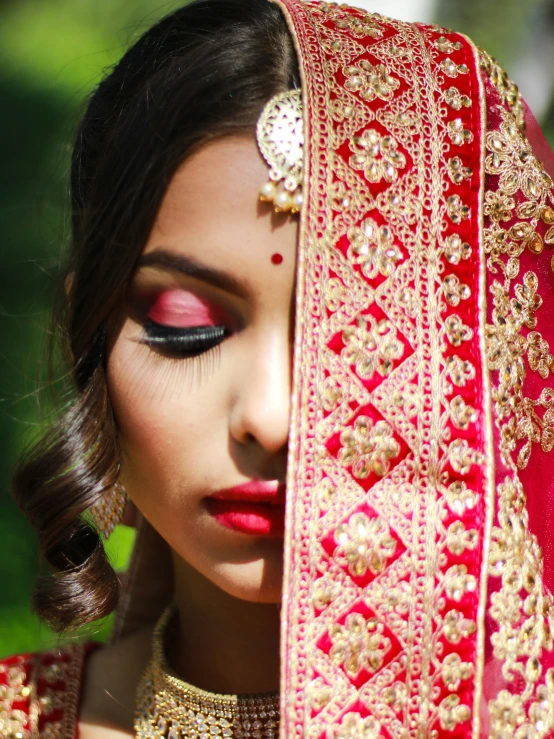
left=108, top=137, right=298, bottom=602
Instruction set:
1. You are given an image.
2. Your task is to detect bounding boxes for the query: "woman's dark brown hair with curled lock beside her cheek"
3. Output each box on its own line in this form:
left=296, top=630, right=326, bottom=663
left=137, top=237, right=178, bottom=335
left=13, top=0, right=300, bottom=631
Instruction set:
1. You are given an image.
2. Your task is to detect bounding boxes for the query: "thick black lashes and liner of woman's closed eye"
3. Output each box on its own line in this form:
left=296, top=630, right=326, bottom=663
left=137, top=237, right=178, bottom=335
left=141, top=321, right=230, bottom=359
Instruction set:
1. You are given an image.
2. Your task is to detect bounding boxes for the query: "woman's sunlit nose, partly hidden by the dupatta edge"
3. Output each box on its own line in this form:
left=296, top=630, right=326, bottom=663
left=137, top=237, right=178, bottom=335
left=229, top=331, right=292, bottom=455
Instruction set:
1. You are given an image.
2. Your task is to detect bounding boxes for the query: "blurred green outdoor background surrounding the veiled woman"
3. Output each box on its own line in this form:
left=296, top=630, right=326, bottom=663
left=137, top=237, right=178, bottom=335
left=0, top=0, right=554, bottom=657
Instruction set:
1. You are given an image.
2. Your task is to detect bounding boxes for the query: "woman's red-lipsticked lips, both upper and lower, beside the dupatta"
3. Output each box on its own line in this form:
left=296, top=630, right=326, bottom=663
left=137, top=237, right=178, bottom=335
left=206, top=480, right=285, bottom=537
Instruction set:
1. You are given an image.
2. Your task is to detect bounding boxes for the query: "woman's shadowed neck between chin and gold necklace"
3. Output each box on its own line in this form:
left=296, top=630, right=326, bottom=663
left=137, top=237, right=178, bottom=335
left=167, top=558, right=280, bottom=695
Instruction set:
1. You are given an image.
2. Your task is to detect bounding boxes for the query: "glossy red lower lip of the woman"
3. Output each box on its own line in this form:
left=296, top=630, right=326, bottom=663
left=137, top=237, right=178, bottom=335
left=206, top=498, right=285, bottom=537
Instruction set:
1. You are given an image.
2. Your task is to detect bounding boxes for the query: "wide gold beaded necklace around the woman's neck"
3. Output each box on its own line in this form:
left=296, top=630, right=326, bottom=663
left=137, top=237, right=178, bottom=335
left=135, top=608, right=279, bottom=739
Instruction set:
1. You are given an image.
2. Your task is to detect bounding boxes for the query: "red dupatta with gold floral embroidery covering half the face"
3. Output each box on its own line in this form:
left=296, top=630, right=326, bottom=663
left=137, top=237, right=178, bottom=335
left=278, top=0, right=554, bottom=739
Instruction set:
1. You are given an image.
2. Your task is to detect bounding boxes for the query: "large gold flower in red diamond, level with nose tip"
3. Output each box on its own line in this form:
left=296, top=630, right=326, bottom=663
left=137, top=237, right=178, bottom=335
left=339, top=416, right=400, bottom=479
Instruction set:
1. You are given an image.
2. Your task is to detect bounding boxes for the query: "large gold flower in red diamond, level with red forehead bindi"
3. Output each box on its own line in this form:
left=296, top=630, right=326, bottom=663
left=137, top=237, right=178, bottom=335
left=348, top=218, right=402, bottom=279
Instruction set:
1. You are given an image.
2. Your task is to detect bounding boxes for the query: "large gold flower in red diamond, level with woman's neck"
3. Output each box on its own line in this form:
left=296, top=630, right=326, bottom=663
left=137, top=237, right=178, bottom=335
left=329, top=613, right=391, bottom=678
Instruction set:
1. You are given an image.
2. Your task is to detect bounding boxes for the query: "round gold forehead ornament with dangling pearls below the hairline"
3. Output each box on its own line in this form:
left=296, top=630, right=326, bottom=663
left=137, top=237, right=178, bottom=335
left=256, top=90, right=304, bottom=213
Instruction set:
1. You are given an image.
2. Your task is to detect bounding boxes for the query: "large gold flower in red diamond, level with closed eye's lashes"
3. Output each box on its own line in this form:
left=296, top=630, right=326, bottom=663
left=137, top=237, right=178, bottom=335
left=341, top=315, right=404, bottom=380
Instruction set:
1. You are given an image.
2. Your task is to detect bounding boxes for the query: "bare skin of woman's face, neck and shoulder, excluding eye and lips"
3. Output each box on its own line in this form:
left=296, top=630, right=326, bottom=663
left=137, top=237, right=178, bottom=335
left=80, top=137, right=298, bottom=739
